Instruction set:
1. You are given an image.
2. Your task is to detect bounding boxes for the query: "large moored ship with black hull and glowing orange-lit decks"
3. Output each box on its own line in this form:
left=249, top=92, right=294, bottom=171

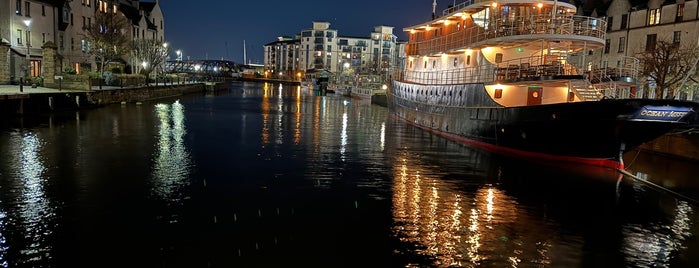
left=388, top=0, right=699, bottom=168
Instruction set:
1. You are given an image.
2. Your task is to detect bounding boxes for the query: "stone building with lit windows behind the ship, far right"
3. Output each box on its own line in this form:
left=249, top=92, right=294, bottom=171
left=587, top=0, right=699, bottom=99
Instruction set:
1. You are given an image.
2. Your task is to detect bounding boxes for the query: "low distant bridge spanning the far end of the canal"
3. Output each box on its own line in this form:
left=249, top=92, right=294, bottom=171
left=165, top=60, right=245, bottom=78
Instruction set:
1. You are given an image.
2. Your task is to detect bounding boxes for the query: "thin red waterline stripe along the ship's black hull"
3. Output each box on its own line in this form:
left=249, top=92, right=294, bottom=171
left=391, top=114, right=624, bottom=169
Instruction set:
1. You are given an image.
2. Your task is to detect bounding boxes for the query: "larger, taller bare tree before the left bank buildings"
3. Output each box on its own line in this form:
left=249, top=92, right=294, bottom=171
left=85, top=11, right=129, bottom=77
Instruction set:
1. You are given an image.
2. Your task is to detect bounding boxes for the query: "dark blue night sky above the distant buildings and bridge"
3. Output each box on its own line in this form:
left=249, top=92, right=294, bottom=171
left=160, top=0, right=454, bottom=64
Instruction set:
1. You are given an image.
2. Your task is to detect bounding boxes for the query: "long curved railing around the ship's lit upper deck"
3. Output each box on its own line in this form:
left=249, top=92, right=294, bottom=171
left=406, top=14, right=607, bottom=55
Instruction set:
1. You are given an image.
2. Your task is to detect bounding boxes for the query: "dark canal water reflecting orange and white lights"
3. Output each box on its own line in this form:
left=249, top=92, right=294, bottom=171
left=0, top=82, right=699, bottom=267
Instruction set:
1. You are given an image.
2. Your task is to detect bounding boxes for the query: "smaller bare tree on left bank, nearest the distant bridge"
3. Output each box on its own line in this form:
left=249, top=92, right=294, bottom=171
left=133, top=39, right=170, bottom=83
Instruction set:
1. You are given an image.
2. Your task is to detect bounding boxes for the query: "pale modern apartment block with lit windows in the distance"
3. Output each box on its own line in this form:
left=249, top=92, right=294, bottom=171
left=264, top=21, right=402, bottom=79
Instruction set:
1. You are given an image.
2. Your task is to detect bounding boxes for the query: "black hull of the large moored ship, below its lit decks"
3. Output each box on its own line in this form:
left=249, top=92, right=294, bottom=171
left=388, top=81, right=699, bottom=167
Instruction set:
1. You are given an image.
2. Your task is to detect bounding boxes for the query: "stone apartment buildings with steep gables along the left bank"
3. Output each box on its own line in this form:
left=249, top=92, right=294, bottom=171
left=0, top=0, right=165, bottom=83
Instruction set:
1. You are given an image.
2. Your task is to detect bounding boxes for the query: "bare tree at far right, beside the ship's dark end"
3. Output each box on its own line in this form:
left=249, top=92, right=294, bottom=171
left=636, top=40, right=699, bottom=99
